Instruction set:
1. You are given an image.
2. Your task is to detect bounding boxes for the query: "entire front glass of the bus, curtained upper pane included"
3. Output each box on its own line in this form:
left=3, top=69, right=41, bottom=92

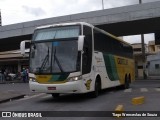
left=30, top=26, right=80, bottom=74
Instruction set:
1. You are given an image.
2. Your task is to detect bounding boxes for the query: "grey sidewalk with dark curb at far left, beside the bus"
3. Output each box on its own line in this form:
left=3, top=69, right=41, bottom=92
left=0, top=80, right=29, bottom=103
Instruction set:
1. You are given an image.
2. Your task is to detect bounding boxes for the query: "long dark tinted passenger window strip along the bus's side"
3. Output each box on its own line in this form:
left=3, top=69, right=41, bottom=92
left=94, top=29, right=133, bottom=58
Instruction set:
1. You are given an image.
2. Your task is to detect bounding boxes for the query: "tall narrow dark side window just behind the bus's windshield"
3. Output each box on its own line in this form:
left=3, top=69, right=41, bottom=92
left=82, top=26, right=92, bottom=74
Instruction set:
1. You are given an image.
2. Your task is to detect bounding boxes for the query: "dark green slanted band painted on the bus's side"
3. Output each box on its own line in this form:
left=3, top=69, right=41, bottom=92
left=103, top=54, right=119, bottom=81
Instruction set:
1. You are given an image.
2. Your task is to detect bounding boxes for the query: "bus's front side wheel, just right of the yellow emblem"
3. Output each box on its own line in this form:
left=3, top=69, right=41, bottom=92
left=91, top=79, right=101, bottom=98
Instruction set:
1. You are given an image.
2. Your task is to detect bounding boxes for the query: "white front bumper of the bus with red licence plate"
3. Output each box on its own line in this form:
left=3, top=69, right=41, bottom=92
left=29, top=80, right=87, bottom=93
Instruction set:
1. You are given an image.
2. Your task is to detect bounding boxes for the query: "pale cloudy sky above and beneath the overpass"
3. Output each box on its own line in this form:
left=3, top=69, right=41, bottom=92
left=0, top=0, right=160, bottom=43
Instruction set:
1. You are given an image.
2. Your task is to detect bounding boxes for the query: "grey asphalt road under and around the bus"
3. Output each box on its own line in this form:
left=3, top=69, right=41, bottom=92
left=0, top=80, right=160, bottom=120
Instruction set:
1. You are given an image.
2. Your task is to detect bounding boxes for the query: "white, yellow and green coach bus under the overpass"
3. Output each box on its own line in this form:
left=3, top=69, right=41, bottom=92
left=21, top=22, right=135, bottom=98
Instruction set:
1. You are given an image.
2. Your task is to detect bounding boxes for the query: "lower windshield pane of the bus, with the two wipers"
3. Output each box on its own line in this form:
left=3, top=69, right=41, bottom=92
left=30, top=40, right=80, bottom=73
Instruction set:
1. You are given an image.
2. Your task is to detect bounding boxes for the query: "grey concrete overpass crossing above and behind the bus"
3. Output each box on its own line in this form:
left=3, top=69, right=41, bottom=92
left=0, top=2, right=160, bottom=73
